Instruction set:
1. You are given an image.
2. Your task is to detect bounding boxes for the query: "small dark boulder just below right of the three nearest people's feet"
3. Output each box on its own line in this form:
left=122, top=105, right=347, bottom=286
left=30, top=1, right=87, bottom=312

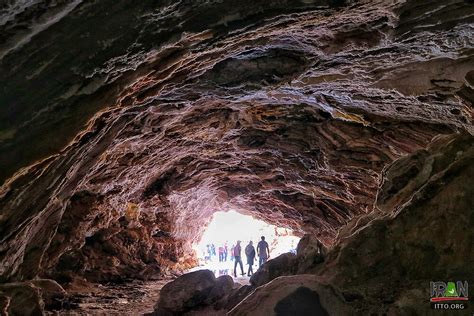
left=250, top=252, right=296, bottom=287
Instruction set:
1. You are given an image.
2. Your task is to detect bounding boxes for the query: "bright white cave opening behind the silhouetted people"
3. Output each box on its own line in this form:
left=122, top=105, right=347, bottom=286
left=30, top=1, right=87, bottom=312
left=193, top=210, right=300, bottom=276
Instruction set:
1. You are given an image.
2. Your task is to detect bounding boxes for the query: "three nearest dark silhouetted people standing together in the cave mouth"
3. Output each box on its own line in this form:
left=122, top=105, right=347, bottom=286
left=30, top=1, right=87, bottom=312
left=232, top=236, right=270, bottom=277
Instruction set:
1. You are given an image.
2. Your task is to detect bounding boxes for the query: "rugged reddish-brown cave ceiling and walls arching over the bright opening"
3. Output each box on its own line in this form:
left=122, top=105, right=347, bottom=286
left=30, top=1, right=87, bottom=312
left=0, top=0, right=474, bottom=312
